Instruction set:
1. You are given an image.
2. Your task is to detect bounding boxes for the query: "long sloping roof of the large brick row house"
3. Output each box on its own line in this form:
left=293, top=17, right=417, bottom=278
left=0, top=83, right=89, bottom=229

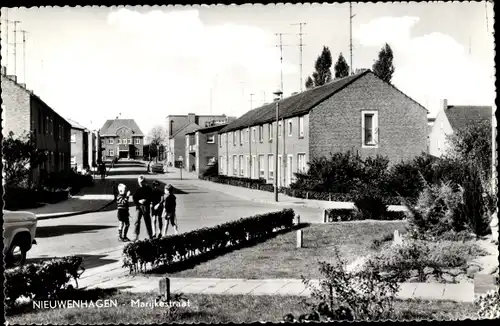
left=220, top=70, right=371, bottom=132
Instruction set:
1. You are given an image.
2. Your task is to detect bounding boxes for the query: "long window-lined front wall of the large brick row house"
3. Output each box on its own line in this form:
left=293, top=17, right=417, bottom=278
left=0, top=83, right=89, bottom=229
left=218, top=114, right=310, bottom=185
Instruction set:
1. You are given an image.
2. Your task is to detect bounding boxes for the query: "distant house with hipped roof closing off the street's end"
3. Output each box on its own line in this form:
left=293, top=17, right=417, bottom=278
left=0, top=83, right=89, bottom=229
left=99, top=119, right=144, bottom=161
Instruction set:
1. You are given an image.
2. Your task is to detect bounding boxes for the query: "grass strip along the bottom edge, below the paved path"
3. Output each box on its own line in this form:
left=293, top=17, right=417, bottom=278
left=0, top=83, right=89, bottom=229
left=6, top=290, right=476, bottom=325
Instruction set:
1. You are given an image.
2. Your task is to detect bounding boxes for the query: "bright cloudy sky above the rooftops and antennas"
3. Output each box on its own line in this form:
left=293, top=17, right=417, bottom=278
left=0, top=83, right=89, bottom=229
left=2, top=2, right=496, bottom=134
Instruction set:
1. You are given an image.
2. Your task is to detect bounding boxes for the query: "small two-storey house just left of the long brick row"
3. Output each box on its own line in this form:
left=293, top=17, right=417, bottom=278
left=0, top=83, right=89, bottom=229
left=184, top=124, right=227, bottom=175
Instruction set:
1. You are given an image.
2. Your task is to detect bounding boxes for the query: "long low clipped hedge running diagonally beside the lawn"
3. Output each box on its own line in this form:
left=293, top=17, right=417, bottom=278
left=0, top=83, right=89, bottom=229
left=123, top=209, right=295, bottom=273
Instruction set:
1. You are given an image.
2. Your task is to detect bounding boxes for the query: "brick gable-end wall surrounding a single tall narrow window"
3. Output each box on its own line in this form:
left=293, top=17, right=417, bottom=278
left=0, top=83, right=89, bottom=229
left=309, top=74, right=428, bottom=163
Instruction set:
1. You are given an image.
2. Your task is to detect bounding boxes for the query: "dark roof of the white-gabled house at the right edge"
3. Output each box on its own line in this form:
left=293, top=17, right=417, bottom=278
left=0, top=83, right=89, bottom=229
left=445, top=105, right=492, bottom=130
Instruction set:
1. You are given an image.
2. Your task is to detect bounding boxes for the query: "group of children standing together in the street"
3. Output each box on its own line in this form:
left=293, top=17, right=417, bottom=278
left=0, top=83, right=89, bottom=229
left=116, top=180, right=179, bottom=242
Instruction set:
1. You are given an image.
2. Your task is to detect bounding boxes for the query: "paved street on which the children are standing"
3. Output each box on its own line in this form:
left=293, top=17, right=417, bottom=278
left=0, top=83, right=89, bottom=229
left=28, top=160, right=319, bottom=268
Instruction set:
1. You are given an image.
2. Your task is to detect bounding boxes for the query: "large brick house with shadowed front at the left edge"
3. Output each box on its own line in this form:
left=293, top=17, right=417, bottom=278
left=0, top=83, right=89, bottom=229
left=1, top=67, right=71, bottom=185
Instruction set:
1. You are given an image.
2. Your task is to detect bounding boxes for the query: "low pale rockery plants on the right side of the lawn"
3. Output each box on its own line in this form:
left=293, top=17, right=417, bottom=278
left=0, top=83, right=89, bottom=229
left=373, top=238, right=484, bottom=282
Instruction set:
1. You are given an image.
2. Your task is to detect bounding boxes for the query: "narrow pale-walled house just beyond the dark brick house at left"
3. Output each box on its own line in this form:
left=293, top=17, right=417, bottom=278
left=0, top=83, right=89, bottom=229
left=68, top=119, right=92, bottom=172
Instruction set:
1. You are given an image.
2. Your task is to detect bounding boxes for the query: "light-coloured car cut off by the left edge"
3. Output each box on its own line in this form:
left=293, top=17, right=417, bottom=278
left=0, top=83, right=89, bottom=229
left=3, top=210, right=37, bottom=267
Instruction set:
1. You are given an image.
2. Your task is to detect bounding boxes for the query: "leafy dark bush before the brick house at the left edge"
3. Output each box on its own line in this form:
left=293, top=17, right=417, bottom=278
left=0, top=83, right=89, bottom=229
left=2, top=131, right=47, bottom=188
